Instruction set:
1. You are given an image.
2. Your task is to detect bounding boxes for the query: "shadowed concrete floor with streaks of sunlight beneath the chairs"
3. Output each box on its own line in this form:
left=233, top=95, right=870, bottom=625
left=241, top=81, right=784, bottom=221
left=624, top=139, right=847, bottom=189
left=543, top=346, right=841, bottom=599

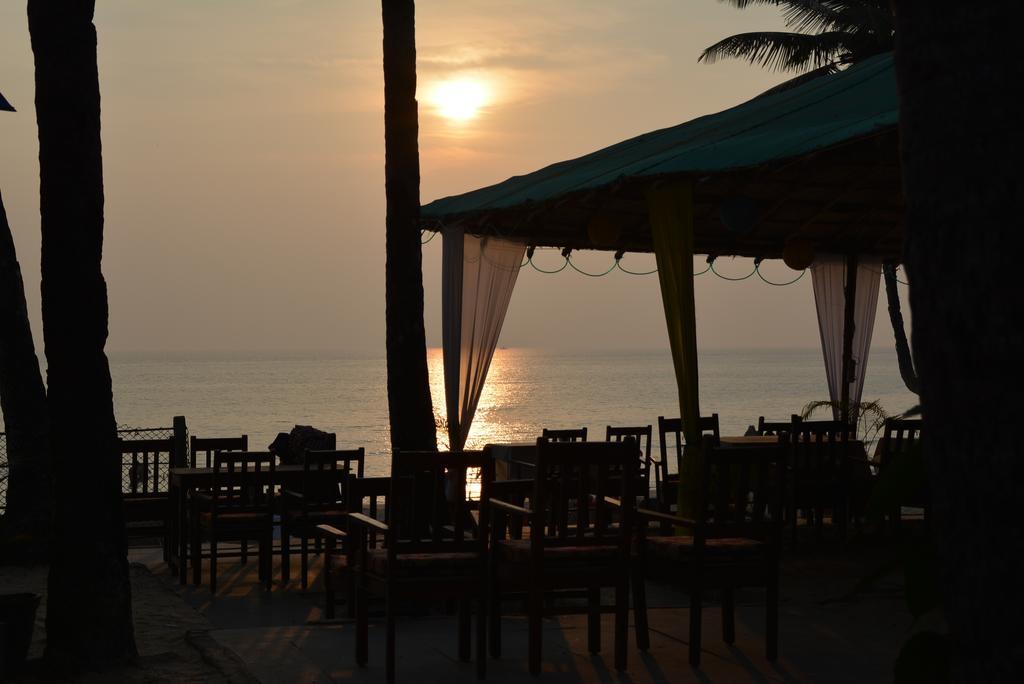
left=131, top=543, right=912, bottom=684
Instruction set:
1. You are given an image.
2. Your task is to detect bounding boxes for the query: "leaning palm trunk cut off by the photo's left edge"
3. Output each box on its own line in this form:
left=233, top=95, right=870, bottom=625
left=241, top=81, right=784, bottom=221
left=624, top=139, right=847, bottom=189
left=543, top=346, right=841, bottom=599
left=0, top=188, right=53, bottom=551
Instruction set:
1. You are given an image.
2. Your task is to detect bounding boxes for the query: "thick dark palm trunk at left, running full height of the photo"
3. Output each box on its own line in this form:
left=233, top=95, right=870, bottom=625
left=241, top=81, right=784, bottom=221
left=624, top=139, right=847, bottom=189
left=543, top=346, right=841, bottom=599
left=29, top=0, right=136, bottom=670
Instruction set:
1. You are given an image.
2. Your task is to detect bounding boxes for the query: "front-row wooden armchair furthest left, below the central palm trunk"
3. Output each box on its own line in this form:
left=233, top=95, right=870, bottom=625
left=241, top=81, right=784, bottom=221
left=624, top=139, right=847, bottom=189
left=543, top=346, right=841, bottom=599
left=347, top=452, right=494, bottom=682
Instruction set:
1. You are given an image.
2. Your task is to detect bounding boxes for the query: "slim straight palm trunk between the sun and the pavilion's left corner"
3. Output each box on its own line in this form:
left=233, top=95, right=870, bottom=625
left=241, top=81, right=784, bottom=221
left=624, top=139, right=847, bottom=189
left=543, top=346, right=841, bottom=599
left=382, top=0, right=437, bottom=456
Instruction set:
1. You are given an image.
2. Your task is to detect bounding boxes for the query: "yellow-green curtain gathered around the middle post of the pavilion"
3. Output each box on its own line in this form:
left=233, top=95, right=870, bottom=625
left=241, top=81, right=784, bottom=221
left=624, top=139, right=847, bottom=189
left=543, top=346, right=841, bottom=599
left=646, top=180, right=700, bottom=517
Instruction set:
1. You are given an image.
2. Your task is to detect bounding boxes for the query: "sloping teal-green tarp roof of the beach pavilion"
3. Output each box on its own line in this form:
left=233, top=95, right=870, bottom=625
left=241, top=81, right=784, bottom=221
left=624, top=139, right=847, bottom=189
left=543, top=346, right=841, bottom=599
left=422, top=54, right=899, bottom=222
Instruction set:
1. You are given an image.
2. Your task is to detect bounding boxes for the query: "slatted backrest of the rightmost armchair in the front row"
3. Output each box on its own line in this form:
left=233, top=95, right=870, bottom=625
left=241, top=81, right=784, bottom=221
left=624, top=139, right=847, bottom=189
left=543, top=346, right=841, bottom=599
left=694, top=435, right=787, bottom=545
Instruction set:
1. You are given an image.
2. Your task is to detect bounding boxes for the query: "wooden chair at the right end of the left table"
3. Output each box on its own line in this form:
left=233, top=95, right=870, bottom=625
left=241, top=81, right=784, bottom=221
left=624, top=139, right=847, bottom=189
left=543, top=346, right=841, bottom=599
left=281, top=446, right=366, bottom=591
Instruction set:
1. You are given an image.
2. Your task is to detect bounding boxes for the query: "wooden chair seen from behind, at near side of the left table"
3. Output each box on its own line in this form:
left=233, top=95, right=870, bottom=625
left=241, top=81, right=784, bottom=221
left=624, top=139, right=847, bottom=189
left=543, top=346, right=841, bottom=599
left=190, top=452, right=275, bottom=593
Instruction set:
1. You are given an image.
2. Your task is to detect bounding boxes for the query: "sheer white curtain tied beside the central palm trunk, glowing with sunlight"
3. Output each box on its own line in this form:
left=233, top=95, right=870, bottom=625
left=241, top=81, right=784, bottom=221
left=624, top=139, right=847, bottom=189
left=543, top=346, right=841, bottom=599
left=441, top=228, right=526, bottom=450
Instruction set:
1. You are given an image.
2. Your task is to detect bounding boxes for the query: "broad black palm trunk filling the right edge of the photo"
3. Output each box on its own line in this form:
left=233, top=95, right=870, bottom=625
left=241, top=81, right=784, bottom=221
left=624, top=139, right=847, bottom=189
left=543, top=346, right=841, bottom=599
left=896, top=0, right=1024, bottom=682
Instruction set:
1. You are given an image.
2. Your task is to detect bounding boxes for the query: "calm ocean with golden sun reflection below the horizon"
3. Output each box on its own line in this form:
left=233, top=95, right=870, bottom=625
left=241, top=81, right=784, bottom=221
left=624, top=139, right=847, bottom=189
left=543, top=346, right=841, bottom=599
left=101, top=348, right=916, bottom=475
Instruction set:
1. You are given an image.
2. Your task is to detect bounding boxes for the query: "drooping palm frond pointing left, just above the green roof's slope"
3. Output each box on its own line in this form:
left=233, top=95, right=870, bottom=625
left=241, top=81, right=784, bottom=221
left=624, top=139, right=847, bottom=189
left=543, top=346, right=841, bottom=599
left=697, top=32, right=849, bottom=71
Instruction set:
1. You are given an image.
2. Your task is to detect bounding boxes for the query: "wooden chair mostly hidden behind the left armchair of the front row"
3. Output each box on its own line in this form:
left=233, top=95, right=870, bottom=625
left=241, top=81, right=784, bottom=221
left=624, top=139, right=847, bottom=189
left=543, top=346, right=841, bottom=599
left=317, top=477, right=391, bottom=619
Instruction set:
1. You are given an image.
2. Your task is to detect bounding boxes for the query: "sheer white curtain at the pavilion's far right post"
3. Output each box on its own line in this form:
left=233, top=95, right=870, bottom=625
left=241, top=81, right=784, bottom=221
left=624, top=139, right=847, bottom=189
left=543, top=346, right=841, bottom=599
left=811, top=255, right=882, bottom=419
